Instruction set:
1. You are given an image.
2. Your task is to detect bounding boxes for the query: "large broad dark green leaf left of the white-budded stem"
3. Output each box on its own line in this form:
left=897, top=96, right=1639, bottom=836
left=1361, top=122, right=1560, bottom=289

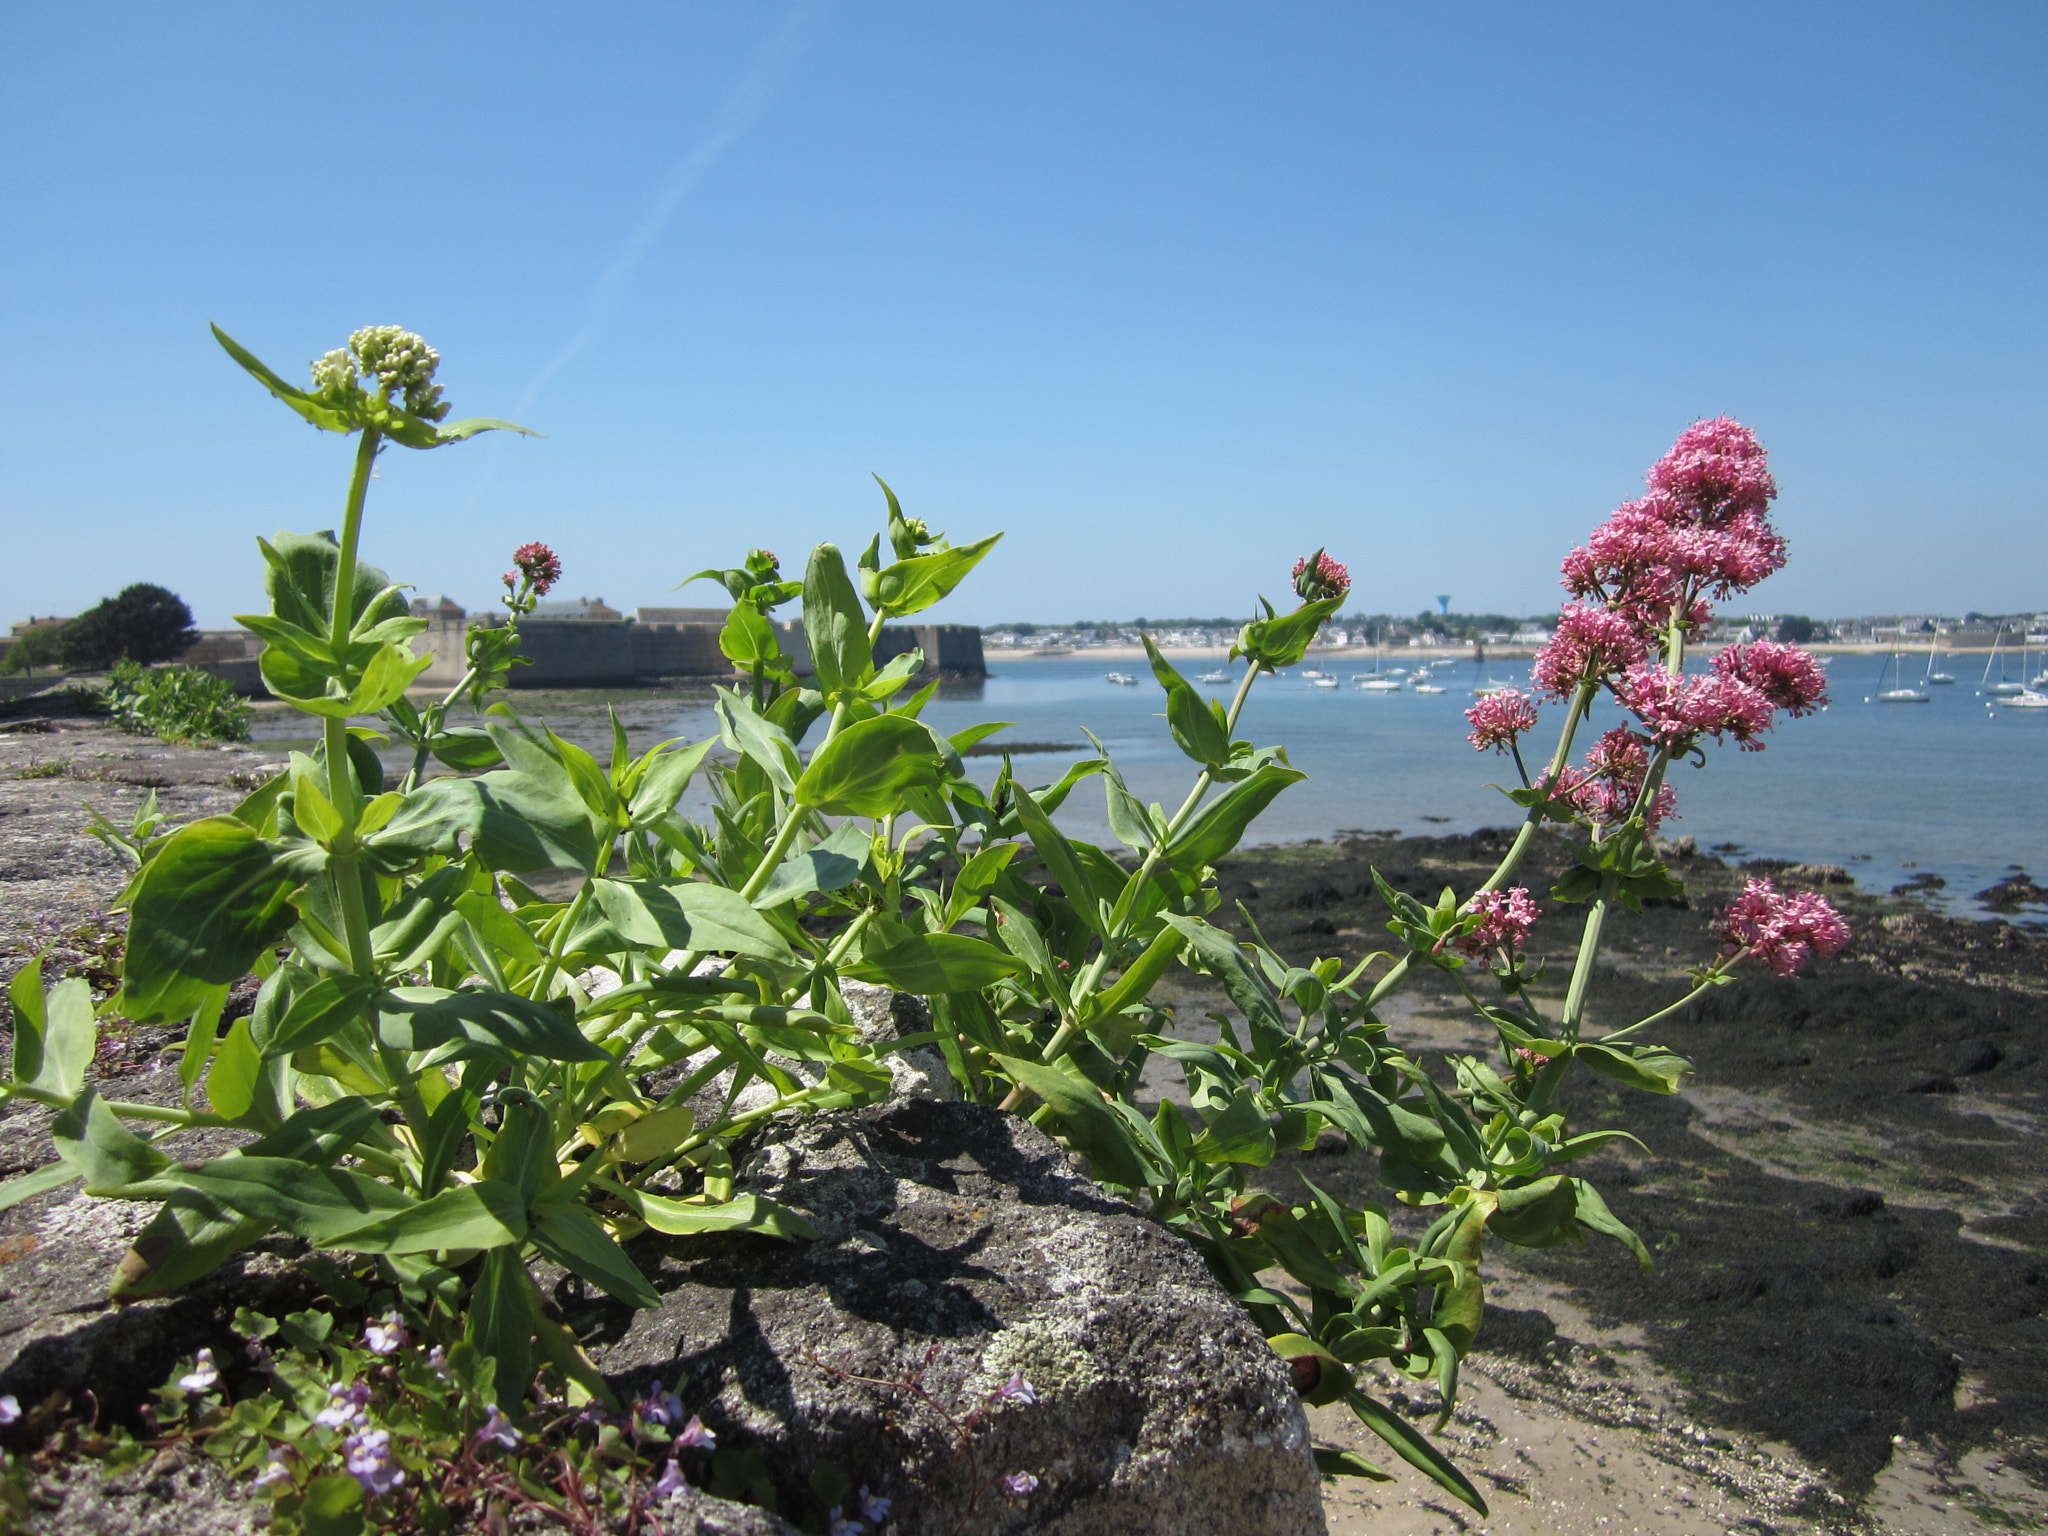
left=121, top=815, right=297, bottom=1022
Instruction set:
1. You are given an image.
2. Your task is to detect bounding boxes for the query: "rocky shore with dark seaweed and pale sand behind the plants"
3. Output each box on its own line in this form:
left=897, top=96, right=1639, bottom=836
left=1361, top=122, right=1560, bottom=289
left=0, top=717, right=2048, bottom=1534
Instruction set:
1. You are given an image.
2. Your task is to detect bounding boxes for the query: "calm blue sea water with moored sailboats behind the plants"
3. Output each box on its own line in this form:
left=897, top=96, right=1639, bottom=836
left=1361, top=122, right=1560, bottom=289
left=288, top=655, right=2048, bottom=913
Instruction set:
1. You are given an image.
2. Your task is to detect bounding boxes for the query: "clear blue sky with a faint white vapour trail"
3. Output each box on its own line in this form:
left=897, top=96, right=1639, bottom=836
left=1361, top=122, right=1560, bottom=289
left=0, top=0, right=2048, bottom=625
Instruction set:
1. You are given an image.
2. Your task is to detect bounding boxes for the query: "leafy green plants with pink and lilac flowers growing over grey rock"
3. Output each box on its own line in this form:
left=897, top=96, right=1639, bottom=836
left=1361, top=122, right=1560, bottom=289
left=0, top=342, right=1843, bottom=1530
